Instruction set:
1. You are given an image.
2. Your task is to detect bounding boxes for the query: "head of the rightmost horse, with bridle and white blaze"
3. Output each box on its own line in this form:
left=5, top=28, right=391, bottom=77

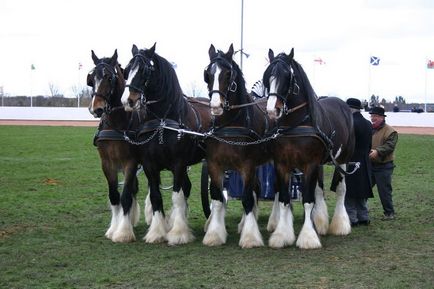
left=263, top=48, right=300, bottom=119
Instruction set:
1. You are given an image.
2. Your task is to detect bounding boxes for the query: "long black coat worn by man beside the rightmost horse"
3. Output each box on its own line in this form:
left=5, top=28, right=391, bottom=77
left=345, top=111, right=374, bottom=199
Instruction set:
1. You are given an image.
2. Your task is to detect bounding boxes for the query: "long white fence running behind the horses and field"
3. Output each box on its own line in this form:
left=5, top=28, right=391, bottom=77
left=0, top=106, right=434, bottom=127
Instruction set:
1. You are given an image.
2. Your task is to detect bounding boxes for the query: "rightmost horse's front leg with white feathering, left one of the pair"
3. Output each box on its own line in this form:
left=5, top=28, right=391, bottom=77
left=268, top=166, right=295, bottom=248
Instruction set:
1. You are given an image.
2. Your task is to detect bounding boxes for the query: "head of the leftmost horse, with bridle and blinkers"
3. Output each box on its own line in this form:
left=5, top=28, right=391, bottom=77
left=87, top=50, right=125, bottom=117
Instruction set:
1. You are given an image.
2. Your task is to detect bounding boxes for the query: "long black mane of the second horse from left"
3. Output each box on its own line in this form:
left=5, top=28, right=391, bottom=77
left=149, top=53, right=188, bottom=117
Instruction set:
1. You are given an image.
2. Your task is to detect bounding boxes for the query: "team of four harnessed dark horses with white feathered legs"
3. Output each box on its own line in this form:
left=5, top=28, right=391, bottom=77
left=87, top=44, right=354, bottom=249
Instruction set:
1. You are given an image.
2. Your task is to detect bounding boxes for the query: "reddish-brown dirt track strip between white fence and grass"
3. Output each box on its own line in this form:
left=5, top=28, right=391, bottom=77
left=0, top=120, right=434, bottom=135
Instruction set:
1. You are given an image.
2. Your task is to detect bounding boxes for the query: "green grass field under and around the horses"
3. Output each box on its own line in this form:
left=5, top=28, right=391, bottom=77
left=0, top=126, right=434, bottom=288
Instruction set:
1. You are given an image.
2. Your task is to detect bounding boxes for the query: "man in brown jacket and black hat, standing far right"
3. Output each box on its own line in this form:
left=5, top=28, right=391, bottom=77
left=369, top=107, right=398, bottom=220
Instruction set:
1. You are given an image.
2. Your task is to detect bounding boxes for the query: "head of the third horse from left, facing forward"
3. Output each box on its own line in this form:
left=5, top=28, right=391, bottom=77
left=204, top=44, right=245, bottom=115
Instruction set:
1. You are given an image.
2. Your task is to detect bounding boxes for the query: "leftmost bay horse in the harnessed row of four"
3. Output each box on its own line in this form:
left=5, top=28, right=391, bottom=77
left=87, top=50, right=140, bottom=242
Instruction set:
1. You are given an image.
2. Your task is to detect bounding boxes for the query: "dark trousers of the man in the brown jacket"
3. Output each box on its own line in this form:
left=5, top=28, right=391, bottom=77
left=372, top=162, right=395, bottom=215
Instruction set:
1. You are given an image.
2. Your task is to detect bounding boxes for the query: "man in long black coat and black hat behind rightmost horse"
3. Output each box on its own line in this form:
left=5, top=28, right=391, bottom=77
left=345, top=98, right=374, bottom=227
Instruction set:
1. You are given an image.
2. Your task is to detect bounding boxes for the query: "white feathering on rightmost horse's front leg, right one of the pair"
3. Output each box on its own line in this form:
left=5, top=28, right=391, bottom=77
left=296, top=203, right=321, bottom=249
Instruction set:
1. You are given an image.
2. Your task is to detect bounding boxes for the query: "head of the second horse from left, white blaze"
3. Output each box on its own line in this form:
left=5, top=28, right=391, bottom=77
left=122, top=43, right=156, bottom=111
